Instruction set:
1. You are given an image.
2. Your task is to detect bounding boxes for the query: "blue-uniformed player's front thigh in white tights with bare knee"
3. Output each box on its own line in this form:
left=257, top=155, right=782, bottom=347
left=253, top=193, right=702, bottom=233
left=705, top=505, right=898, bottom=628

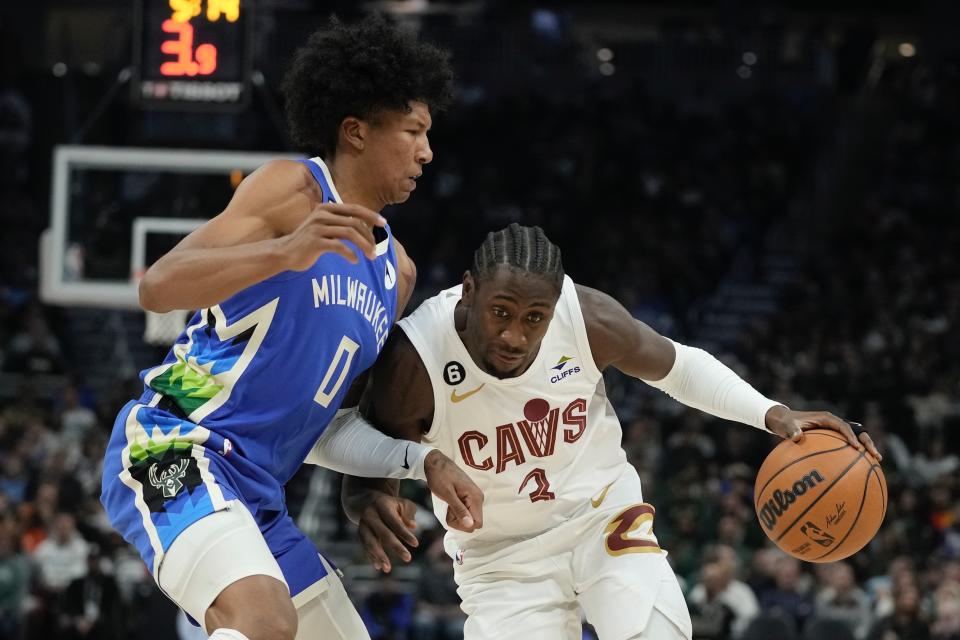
left=157, top=501, right=295, bottom=632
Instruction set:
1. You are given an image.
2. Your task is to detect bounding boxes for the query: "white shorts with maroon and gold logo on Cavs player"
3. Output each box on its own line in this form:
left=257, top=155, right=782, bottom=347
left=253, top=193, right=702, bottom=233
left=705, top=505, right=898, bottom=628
left=453, top=467, right=693, bottom=640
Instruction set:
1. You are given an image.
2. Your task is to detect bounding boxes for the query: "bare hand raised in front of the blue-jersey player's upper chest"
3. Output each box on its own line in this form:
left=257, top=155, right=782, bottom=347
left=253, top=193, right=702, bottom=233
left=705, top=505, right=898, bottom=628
left=277, top=202, right=387, bottom=271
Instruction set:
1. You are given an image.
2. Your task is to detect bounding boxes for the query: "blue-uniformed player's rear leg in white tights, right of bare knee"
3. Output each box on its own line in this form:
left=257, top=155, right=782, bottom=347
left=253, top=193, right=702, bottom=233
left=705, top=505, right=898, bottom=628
left=294, top=560, right=370, bottom=640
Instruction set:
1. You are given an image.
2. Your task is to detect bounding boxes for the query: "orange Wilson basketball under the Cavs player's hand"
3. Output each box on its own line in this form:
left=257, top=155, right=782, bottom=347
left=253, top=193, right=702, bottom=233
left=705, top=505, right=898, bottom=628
left=754, top=429, right=887, bottom=562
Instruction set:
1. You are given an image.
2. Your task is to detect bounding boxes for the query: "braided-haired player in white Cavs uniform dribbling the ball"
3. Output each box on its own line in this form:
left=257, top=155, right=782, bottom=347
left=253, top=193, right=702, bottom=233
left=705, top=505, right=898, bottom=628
left=344, top=224, right=879, bottom=640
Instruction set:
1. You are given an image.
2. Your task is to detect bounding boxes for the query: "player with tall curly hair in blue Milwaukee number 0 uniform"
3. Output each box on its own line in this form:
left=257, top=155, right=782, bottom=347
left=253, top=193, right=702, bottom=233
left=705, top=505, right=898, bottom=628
left=101, top=18, right=482, bottom=640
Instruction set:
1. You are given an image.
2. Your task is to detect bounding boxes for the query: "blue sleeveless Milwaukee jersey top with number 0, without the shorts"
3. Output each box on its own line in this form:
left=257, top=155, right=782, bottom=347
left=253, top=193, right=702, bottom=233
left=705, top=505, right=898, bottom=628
left=141, top=161, right=397, bottom=484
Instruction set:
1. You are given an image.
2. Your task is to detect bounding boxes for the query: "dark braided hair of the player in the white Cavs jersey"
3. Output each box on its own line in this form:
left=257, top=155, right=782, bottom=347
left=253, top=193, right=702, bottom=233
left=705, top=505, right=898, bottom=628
left=470, top=222, right=563, bottom=291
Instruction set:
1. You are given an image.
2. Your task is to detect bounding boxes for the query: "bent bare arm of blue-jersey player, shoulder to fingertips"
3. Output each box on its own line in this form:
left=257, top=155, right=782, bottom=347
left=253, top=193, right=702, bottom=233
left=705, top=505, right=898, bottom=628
left=140, top=160, right=386, bottom=312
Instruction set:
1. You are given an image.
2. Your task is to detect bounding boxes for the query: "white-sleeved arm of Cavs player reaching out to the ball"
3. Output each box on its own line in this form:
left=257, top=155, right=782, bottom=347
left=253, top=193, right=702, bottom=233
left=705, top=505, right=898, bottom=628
left=577, top=286, right=880, bottom=458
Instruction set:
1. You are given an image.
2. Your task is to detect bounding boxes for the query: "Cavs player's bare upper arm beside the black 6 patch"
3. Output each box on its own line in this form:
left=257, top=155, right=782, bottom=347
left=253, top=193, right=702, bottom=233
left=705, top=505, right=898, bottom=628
left=369, top=327, right=434, bottom=440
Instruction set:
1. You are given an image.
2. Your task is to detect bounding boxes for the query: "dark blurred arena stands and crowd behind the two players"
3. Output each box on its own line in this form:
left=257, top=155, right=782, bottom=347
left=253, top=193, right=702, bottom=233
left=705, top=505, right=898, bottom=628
left=0, top=0, right=960, bottom=640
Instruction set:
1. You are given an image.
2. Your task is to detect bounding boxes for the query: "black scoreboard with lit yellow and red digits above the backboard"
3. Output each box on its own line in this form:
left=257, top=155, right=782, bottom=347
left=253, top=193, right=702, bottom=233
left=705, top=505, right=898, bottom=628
left=133, top=0, right=254, bottom=111
